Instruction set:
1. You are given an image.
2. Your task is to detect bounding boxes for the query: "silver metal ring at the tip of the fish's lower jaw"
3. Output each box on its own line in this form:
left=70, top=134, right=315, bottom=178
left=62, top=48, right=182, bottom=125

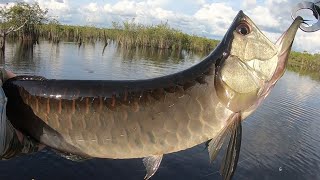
left=291, top=1, right=320, bottom=32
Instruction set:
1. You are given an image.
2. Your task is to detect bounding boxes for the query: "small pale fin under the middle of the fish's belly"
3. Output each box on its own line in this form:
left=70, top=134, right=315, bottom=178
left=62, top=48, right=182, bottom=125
left=142, top=154, right=163, bottom=180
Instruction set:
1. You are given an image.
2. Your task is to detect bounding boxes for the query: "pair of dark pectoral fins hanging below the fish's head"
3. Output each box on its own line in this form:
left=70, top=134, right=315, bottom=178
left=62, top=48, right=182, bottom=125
left=206, top=113, right=242, bottom=180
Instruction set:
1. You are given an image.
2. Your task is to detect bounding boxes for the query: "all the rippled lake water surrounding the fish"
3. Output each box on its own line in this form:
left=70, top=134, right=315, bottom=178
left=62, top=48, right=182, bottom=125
left=0, top=42, right=320, bottom=180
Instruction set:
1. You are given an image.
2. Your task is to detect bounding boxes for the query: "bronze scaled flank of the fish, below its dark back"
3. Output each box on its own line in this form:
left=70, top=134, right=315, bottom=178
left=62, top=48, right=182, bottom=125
left=5, top=65, right=222, bottom=158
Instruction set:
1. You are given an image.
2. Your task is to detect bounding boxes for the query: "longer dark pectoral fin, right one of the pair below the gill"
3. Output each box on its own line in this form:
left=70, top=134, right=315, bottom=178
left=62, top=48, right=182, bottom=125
left=220, top=113, right=242, bottom=180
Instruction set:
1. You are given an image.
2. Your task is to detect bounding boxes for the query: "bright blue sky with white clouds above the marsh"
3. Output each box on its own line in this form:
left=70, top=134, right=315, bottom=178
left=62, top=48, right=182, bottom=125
left=0, top=0, right=320, bottom=53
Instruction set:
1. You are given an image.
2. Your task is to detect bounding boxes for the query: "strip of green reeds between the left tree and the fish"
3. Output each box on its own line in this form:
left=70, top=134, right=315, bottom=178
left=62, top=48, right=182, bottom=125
left=35, top=22, right=219, bottom=52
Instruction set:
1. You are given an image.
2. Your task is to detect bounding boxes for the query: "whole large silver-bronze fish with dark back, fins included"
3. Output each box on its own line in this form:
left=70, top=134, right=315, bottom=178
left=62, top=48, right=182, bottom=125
left=3, top=11, right=303, bottom=179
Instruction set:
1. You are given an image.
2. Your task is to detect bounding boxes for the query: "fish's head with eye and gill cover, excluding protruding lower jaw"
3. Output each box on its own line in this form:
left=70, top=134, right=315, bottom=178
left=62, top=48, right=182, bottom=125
left=215, top=11, right=277, bottom=112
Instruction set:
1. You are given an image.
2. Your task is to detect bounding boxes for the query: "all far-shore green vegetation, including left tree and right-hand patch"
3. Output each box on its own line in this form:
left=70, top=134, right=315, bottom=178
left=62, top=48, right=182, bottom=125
left=0, top=2, right=320, bottom=79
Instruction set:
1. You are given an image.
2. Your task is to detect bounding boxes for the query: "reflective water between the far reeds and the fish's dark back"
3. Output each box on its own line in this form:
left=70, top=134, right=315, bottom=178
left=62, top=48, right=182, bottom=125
left=6, top=41, right=205, bottom=79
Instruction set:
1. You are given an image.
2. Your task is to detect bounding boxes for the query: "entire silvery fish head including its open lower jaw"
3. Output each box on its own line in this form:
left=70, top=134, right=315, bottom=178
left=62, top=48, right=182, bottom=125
left=215, top=11, right=303, bottom=112
